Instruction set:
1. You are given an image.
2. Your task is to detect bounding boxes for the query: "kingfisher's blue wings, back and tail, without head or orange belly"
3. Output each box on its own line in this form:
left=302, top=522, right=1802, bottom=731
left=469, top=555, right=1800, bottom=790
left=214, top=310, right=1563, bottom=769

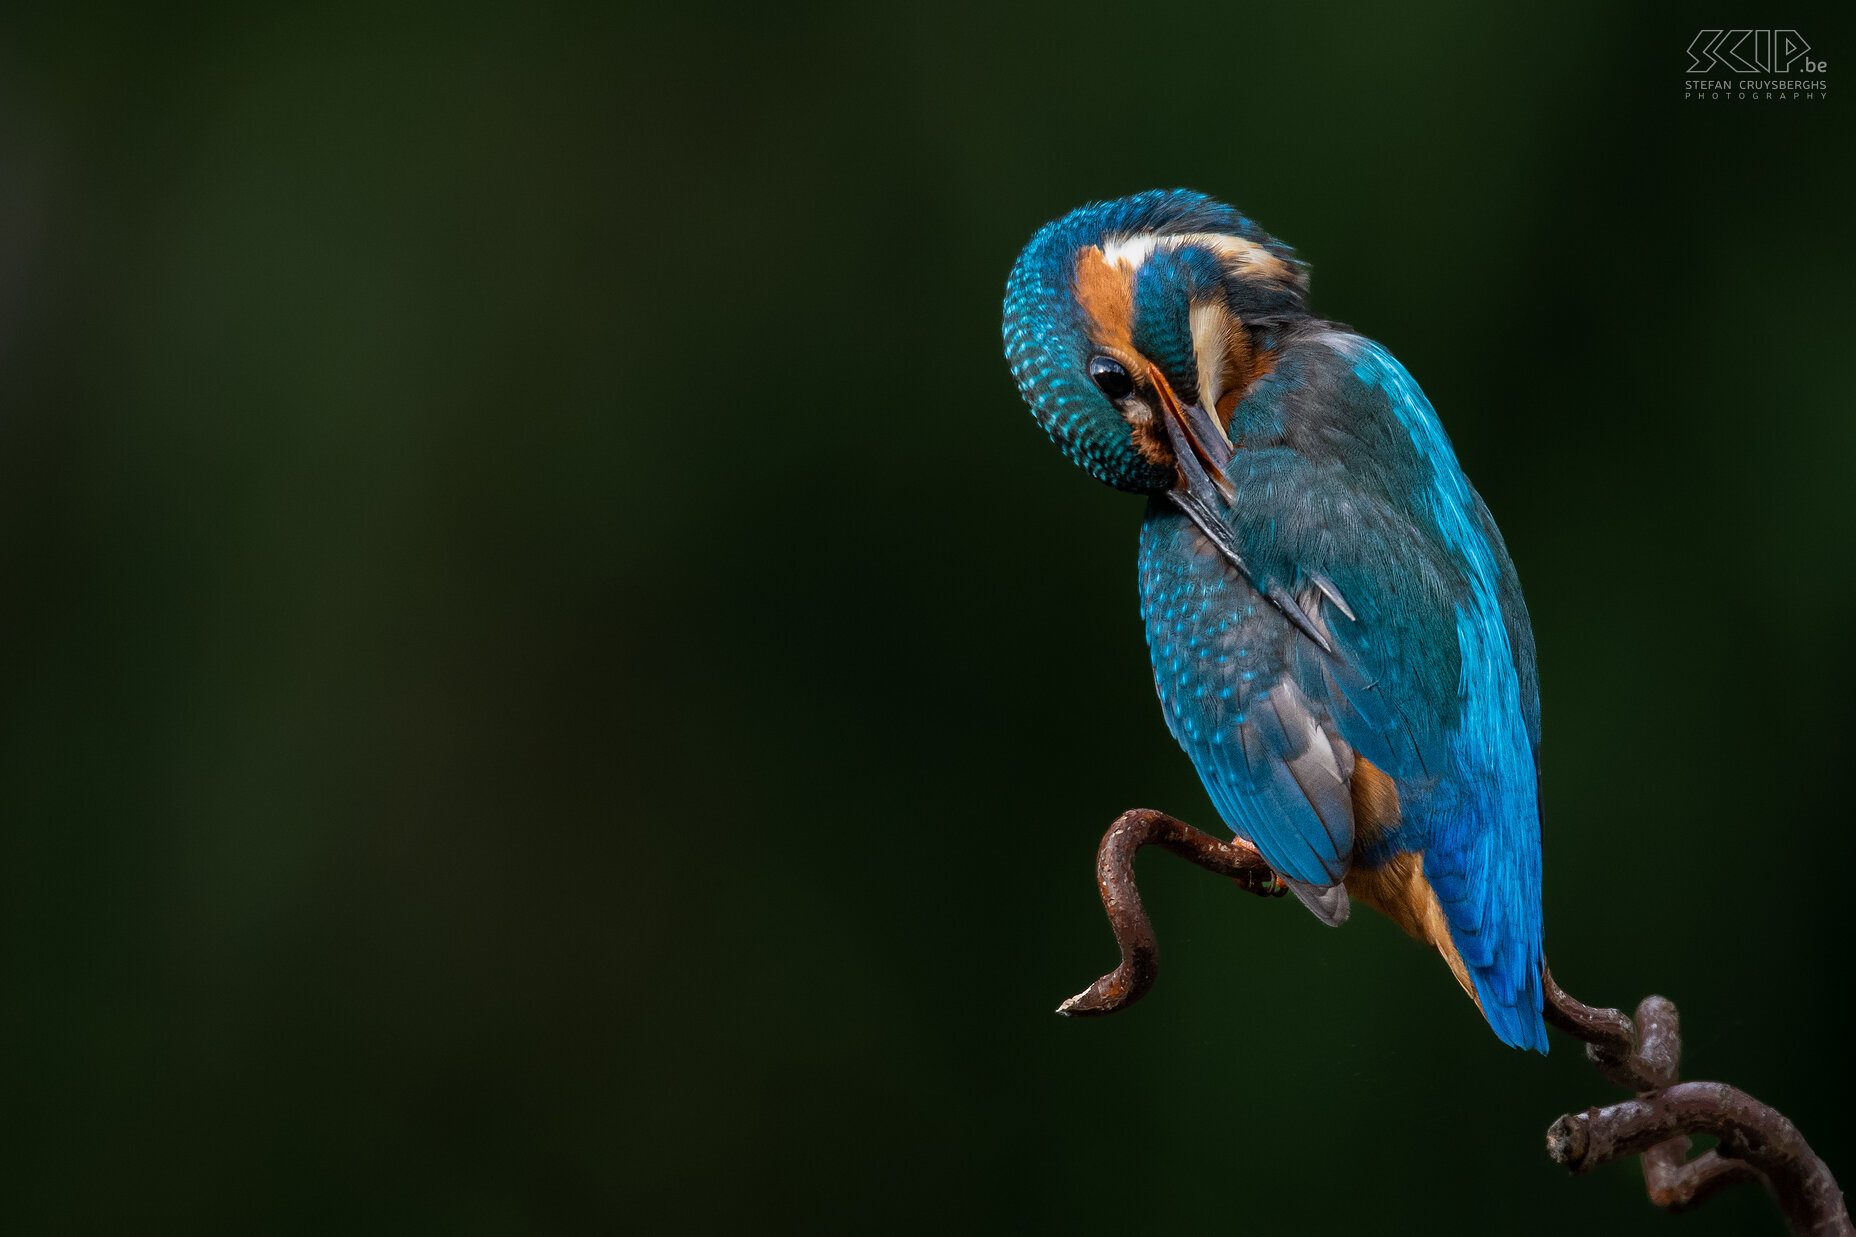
left=1141, top=326, right=1544, bottom=1046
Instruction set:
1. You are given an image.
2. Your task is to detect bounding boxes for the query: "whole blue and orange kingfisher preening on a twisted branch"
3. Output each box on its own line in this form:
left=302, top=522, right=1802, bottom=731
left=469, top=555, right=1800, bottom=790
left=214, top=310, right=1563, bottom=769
left=1004, top=189, right=1546, bottom=1053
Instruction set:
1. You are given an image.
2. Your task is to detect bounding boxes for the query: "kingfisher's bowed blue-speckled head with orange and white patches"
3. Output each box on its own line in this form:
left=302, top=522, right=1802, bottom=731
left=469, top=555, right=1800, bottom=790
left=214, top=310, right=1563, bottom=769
left=1006, top=189, right=1308, bottom=494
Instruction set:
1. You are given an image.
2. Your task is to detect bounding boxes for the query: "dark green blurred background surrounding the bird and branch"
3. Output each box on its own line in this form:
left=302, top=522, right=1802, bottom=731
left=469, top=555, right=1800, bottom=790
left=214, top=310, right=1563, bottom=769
left=0, top=2, right=1856, bottom=1235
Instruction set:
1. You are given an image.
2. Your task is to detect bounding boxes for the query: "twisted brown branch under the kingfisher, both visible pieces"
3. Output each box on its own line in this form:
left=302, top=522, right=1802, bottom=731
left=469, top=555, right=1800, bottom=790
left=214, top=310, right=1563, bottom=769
left=1056, top=808, right=1856, bottom=1237
